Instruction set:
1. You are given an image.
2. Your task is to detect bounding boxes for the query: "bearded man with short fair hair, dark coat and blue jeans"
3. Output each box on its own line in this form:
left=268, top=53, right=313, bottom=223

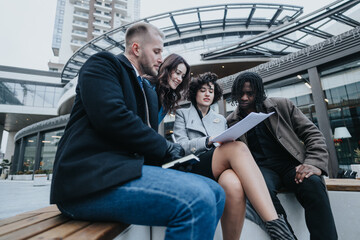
left=50, top=23, right=224, bottom=239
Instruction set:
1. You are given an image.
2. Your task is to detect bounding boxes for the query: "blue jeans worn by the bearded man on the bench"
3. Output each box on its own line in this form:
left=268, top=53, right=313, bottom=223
left=58, top=166, right=225, bottom=240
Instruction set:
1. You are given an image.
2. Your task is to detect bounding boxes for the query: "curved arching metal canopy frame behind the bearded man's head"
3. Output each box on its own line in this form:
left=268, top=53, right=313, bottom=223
left=61, top=3, right=303, bottom=82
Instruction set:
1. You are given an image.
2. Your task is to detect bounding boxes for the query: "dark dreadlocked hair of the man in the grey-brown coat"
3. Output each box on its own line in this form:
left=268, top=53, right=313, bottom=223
left=231, top=72, right=266, bottom=108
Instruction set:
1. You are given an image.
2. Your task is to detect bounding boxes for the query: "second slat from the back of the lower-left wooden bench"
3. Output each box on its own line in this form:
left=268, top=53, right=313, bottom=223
left=0, top=211, right=60, bottom=236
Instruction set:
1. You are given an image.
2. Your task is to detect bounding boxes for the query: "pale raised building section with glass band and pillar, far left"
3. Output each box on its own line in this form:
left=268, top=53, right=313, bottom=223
left=0, top=66, right=64, bottom=172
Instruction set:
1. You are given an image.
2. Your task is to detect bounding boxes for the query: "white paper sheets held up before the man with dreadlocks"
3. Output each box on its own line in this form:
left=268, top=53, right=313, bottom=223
left=212, top=112, right=274, bottom=143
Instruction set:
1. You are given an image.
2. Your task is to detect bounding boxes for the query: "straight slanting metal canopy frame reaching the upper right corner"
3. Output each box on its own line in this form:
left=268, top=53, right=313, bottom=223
left=201, top=0, right=360, bottom=61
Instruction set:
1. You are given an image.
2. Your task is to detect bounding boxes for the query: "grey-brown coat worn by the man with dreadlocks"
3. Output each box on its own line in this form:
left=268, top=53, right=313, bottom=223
left=227, top=97, right=329, bottom=175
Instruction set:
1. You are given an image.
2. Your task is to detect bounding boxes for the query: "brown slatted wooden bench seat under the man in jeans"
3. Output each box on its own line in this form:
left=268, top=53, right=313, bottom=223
left=0, top=205, right=129, bottom=240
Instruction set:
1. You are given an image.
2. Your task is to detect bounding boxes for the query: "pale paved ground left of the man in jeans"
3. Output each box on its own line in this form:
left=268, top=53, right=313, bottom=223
left=0, top=179, right=50, bottom=219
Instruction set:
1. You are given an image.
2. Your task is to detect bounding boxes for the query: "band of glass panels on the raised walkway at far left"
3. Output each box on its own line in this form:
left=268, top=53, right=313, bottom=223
left=0, top=82, right=63, bottom=108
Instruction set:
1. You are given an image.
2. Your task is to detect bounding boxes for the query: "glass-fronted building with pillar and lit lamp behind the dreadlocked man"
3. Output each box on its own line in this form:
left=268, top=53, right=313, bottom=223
left=217, top=25, right=360, bottom=176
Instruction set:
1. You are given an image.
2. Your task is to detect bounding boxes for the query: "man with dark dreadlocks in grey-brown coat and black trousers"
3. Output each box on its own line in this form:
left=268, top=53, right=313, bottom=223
left=227, top=72, right=337, bottom=240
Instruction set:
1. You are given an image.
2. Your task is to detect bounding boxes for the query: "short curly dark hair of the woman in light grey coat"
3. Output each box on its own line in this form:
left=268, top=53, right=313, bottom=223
left=187, top=72, right=222, bottom=106
